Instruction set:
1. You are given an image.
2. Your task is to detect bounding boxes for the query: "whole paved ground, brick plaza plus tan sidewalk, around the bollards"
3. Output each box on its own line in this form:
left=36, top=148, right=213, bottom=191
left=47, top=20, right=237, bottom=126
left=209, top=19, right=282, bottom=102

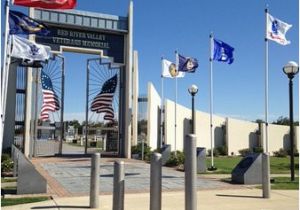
left=2, top=156, right=299, bottom=210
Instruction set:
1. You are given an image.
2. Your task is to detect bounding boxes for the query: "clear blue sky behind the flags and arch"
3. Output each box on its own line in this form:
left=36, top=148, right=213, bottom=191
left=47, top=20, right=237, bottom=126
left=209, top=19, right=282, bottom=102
left=2, top=0, right=299, bottom=121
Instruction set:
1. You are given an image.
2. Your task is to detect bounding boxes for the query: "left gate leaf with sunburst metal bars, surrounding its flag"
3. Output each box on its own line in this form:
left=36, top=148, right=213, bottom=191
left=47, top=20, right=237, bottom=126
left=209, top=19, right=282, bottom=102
left=31, top=55, right=65, bottom=157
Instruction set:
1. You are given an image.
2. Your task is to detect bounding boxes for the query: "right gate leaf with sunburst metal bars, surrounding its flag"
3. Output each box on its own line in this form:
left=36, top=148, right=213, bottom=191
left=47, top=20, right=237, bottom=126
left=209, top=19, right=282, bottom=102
left=85, top=58, right=121, bottom=154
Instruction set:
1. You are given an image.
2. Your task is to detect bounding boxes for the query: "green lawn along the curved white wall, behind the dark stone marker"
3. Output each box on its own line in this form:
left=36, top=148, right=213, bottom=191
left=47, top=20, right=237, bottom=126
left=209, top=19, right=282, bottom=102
left=206, top=156, right=299, bottom=174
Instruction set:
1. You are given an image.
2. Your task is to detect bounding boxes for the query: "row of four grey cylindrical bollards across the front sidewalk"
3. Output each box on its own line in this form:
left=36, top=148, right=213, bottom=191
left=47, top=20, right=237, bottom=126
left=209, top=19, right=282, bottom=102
left=90, top=134, right=197, bottom=210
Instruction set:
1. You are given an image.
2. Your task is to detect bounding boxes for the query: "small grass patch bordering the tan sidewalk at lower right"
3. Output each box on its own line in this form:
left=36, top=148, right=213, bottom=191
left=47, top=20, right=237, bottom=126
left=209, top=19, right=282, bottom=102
left=257, top=177, right=299, bottom=190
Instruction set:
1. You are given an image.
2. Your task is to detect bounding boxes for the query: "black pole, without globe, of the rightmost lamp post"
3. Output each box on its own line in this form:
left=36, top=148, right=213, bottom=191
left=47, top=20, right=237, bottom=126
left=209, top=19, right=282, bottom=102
left=289, top=77, right=295, bottom=181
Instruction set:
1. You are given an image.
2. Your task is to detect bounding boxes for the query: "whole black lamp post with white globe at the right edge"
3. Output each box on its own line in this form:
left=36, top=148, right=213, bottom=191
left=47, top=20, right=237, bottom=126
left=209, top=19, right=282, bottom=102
left=283, top=61, right=299, bottom=181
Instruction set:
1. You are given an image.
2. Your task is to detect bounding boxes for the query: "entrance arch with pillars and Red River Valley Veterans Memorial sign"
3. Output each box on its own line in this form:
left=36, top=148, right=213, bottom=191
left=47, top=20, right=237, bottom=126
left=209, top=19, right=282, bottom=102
left=19, top=1, right=133, bottom=158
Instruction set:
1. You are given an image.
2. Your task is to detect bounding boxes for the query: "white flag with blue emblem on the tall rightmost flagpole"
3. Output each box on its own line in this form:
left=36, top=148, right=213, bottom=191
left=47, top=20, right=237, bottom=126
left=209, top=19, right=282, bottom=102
left=266, top=13, right=292, bottom=45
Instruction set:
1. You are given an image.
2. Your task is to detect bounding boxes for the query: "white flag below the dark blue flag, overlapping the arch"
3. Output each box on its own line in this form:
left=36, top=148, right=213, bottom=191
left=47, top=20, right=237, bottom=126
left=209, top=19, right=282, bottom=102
left=11, top=35, right=51, bottom=62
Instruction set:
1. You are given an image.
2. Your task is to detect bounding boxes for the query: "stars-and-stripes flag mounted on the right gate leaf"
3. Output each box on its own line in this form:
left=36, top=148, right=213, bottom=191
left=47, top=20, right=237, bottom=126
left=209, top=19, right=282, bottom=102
left=91, top=74, right=118, bottom=121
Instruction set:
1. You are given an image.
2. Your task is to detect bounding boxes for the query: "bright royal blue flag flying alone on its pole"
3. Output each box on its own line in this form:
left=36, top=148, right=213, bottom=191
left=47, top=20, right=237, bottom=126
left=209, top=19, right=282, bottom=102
left=213, top=39, right=234, bottom=64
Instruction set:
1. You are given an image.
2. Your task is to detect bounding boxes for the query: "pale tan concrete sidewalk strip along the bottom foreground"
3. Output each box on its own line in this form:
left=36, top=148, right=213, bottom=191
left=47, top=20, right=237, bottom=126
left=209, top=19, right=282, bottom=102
left=2, top=188, right=299, bottom=210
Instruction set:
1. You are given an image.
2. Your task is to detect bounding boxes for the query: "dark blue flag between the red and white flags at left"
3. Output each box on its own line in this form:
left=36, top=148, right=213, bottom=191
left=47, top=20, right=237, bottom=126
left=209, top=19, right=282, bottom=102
left=9, top=10, right=50, bottom=36
